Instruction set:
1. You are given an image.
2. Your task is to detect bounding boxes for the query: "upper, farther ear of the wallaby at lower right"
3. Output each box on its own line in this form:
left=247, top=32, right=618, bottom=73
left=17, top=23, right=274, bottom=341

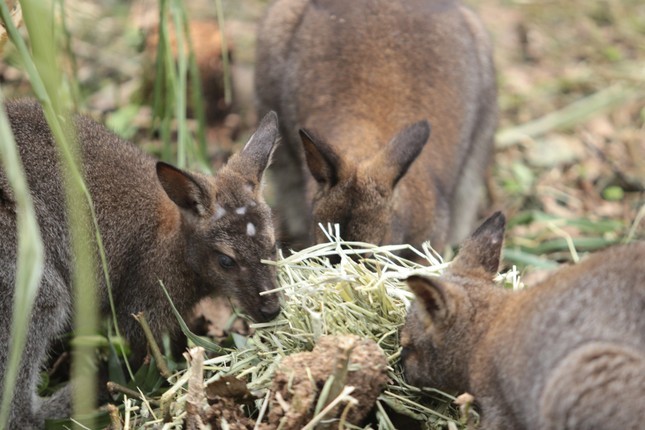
left=450, top=212, right=506, bottom=275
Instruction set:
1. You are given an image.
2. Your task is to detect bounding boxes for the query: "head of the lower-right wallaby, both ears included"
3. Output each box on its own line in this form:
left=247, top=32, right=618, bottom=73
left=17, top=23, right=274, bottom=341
left=401, top=212, right=505, bottom=391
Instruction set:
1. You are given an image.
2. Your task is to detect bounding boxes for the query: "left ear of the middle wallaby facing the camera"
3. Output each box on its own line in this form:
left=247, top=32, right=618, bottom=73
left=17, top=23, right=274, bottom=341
left=299, top=128, right=340, bottom=187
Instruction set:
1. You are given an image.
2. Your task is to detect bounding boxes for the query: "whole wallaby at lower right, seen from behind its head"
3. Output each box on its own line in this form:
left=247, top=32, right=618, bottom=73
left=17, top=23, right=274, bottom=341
left=401, top=213, right=645, bottom=430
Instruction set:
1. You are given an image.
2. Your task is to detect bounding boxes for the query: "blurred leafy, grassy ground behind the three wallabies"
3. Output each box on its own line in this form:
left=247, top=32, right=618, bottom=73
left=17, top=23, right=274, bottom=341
left=0, top=0, right=645, bottom=272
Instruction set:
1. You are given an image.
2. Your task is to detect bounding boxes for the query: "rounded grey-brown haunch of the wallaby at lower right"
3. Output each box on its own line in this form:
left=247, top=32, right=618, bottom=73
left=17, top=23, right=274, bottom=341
left=539, top=342, right=645, bottom=430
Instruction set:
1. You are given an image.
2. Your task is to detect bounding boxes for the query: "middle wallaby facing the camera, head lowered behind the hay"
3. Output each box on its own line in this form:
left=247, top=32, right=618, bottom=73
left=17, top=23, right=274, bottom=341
left=255, top=0, right=497, bottom=250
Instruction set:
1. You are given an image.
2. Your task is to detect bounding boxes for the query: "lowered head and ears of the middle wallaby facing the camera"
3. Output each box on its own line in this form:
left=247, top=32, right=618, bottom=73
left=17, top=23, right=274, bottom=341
left=300, top=120, right=430, bottom=245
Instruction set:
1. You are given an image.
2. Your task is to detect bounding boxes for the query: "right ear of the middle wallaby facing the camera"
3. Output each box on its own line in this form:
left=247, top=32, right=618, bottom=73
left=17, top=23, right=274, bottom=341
left=370, top=120, right=430, bottom=188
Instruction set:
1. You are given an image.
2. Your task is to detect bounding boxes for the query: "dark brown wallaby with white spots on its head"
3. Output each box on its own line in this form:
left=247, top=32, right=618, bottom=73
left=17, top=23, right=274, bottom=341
left=0, top=100, right=280, bottom=428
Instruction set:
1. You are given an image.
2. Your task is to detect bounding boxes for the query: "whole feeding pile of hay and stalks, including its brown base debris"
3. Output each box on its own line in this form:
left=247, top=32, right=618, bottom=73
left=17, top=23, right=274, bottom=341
left=117, top=227, right=518, bottom=429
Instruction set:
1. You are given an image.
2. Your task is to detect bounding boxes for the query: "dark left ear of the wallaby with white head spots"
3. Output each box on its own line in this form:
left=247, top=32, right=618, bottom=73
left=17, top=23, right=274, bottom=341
left=157, top=161, right=207, bottom=215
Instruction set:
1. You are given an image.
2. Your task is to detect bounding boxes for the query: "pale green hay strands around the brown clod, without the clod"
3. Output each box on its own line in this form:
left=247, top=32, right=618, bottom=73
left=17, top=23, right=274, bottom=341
left=118, top=227, right=520, bottom=429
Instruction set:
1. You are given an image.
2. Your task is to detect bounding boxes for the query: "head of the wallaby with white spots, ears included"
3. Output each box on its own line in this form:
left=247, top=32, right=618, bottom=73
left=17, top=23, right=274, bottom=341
left=157, top=112, right=280, bottom=321
